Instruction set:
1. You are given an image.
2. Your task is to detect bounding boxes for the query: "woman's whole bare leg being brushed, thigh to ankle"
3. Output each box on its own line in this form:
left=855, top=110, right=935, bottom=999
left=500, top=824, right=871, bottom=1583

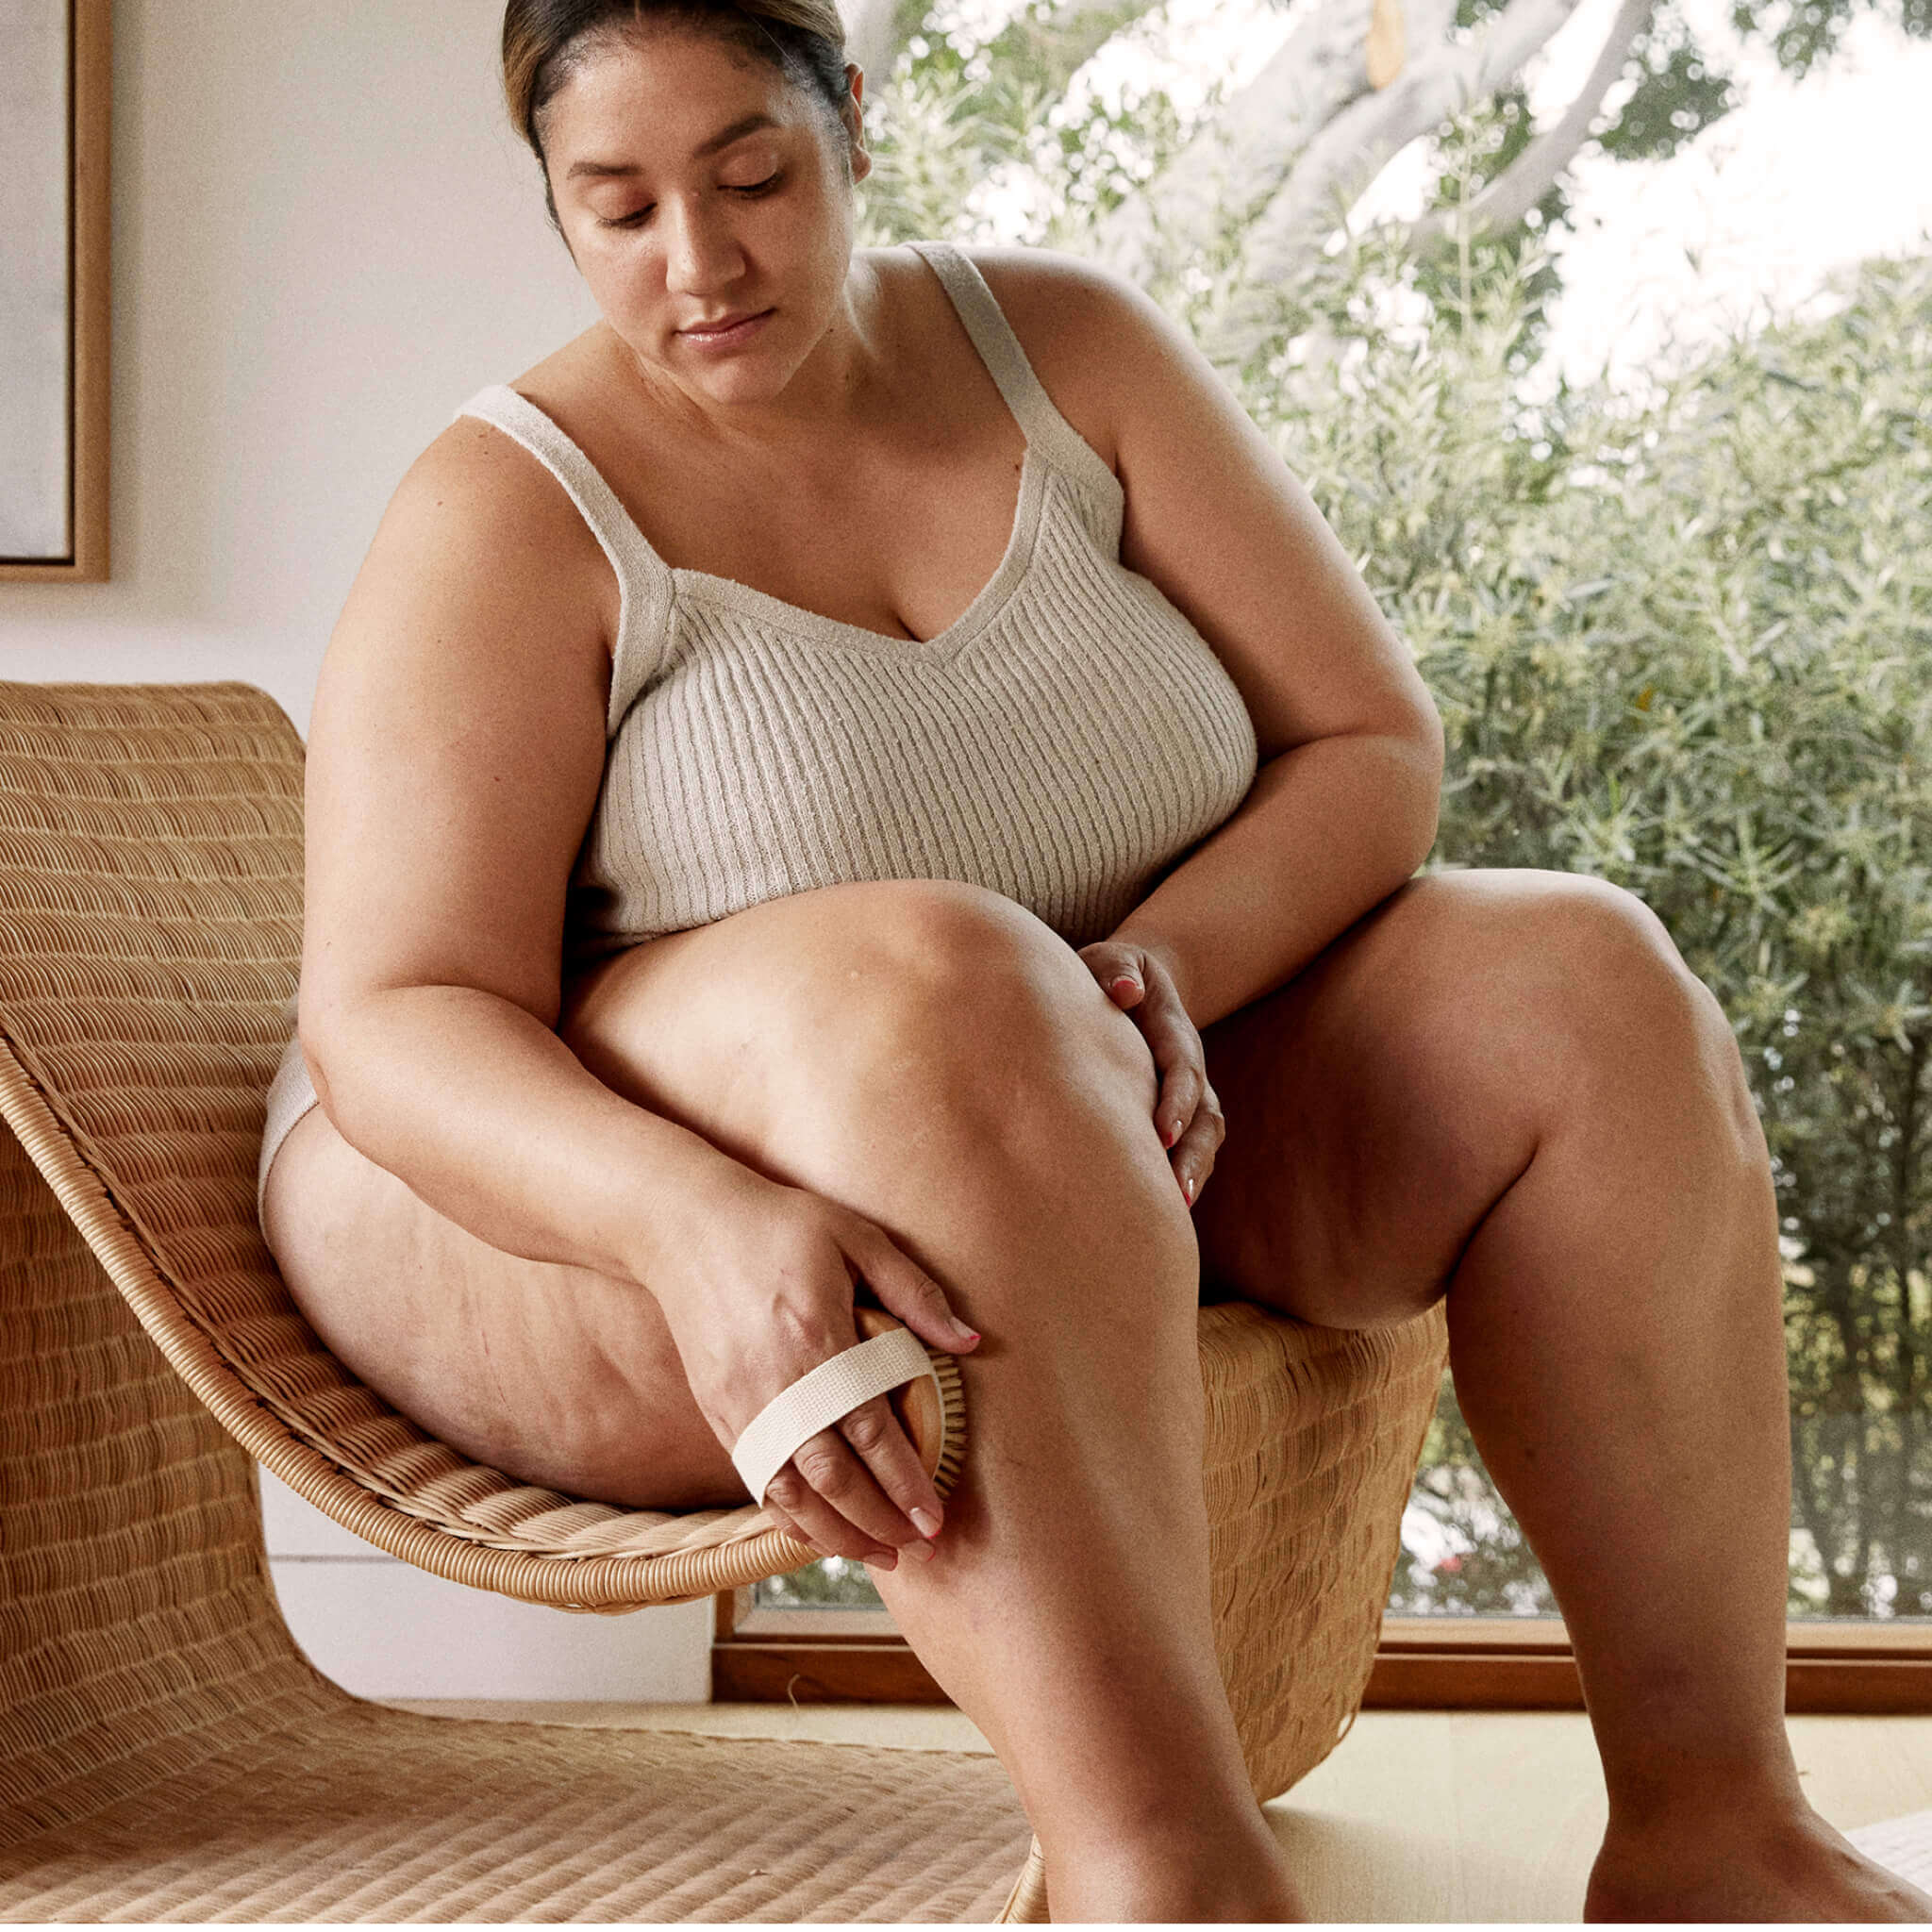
left=271, top=883, right=1298, bottom=1921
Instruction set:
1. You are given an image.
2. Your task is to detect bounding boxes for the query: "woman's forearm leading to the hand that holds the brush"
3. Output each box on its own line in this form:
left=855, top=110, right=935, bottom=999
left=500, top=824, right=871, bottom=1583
left=304, top=985, right=750, bottom=1281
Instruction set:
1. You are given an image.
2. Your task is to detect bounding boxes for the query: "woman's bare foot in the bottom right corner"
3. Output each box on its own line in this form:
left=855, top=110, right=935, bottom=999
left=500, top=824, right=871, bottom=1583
left=1582, top=1805, right=1932, bottom=1924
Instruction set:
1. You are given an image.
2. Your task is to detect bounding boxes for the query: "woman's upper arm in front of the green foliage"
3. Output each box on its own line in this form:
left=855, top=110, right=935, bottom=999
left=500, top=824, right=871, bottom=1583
left=981, top=251, right=1441, bottom=761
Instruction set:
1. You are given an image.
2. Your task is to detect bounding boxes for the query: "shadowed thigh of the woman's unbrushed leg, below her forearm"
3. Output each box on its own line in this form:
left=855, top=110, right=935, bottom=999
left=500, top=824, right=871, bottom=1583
left=1194, top=872, right=1599, bottom=1327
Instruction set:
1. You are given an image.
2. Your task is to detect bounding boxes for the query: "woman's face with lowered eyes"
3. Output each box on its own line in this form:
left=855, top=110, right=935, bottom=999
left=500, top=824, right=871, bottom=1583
left=542, top=24, right=872, bottom=415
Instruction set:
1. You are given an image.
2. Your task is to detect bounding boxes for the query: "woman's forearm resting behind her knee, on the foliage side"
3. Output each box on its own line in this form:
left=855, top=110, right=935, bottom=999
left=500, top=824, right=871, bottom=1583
left=1109, top=734, right=1441, bottom=1030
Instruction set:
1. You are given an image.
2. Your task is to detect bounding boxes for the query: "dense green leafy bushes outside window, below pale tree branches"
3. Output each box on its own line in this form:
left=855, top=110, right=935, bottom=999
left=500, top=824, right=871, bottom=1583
left=1243, top=229, right=1932, bottom=1615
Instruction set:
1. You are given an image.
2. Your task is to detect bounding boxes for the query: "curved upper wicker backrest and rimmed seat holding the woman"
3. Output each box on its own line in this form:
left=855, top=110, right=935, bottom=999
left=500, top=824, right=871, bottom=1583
left=0, top=682, right=809, bottom=1613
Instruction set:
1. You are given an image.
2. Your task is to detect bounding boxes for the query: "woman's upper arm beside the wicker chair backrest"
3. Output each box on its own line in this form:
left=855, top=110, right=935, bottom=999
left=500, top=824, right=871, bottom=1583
left=301, top=419, right=614, bottom=1049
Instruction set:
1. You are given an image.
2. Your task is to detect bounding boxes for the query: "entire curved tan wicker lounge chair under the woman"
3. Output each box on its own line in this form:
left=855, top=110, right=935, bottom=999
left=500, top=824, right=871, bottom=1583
left=0, top=682, right=1445, bottom=1923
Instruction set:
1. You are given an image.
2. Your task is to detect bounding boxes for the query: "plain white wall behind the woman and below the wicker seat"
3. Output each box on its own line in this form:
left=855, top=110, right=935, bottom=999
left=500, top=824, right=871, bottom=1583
left=0, top=0, right=709, bottom=1700
